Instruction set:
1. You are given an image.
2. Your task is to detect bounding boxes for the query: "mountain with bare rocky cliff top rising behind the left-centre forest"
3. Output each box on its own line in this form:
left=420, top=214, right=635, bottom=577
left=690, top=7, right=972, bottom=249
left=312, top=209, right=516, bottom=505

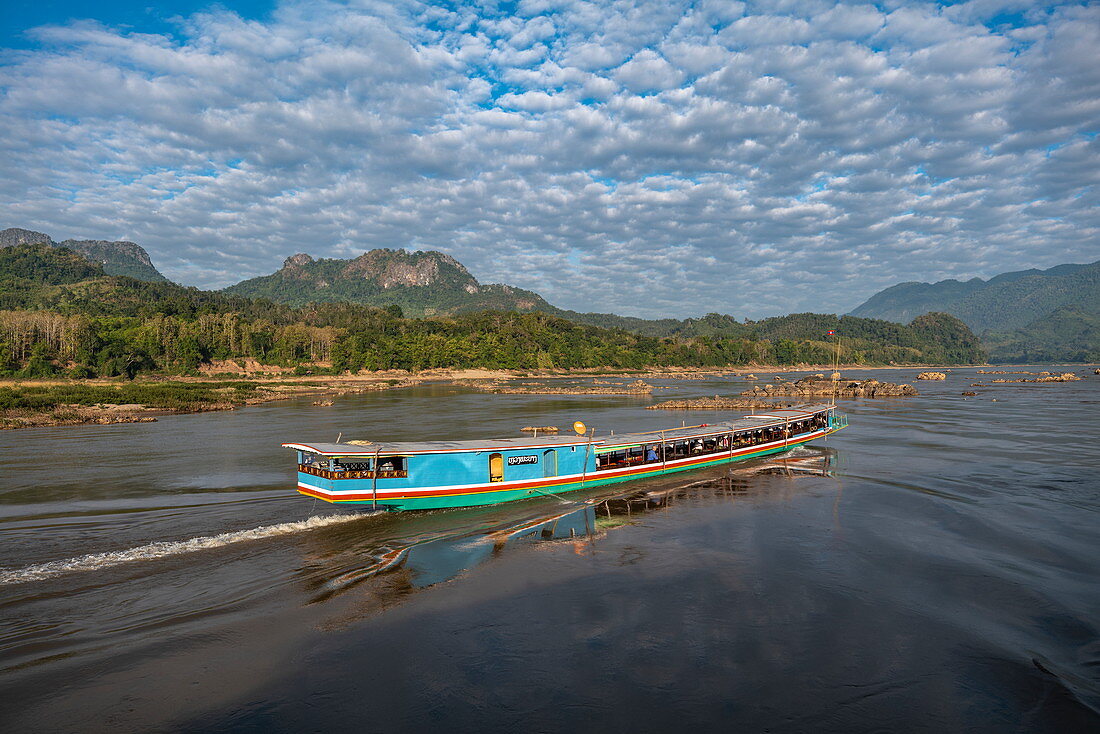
left=226, top=249, right=556, bottom=316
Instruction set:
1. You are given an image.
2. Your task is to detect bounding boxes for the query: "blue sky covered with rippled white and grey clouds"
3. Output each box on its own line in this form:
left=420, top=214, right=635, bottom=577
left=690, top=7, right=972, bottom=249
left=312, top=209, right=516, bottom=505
left=0, top=0, right=1100, bottom=318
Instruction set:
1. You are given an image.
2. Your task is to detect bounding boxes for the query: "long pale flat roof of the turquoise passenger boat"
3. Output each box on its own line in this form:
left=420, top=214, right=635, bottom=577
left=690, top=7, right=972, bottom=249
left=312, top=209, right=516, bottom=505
left=283, top=403, right=836, bottom=457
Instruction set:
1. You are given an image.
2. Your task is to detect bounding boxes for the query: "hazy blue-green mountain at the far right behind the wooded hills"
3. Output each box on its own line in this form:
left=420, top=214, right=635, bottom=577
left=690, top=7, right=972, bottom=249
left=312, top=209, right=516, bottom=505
left=851, top=261, right=1100, bottom=363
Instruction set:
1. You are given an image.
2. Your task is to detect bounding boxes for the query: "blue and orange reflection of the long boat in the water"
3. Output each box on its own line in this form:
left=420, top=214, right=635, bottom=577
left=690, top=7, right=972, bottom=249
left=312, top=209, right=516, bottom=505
left=310, top=447, right=836, bottom=596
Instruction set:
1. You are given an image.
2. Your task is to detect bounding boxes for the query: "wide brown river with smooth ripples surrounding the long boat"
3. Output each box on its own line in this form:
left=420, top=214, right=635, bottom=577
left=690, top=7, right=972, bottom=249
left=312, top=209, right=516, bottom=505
left=0, top=369, right=1100, bottom=732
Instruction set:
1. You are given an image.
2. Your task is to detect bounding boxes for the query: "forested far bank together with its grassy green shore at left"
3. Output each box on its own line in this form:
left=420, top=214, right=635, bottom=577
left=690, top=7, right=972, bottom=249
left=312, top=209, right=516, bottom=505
left=0, top=240, right=986, bottom=421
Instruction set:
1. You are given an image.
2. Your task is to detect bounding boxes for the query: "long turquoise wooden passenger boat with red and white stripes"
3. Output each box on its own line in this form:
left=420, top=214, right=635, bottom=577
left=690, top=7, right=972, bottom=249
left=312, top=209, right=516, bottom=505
left=283, top=405, right=848, bottom=510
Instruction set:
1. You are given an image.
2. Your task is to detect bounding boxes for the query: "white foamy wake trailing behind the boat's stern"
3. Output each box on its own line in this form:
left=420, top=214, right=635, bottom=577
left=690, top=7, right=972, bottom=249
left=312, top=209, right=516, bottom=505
left=0, top=515, right=363, bottom=585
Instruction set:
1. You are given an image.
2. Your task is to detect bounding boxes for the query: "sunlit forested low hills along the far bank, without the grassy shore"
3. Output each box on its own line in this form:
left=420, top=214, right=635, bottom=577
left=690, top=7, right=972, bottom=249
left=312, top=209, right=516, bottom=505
left=0, top=244, right=985, bottom=377
